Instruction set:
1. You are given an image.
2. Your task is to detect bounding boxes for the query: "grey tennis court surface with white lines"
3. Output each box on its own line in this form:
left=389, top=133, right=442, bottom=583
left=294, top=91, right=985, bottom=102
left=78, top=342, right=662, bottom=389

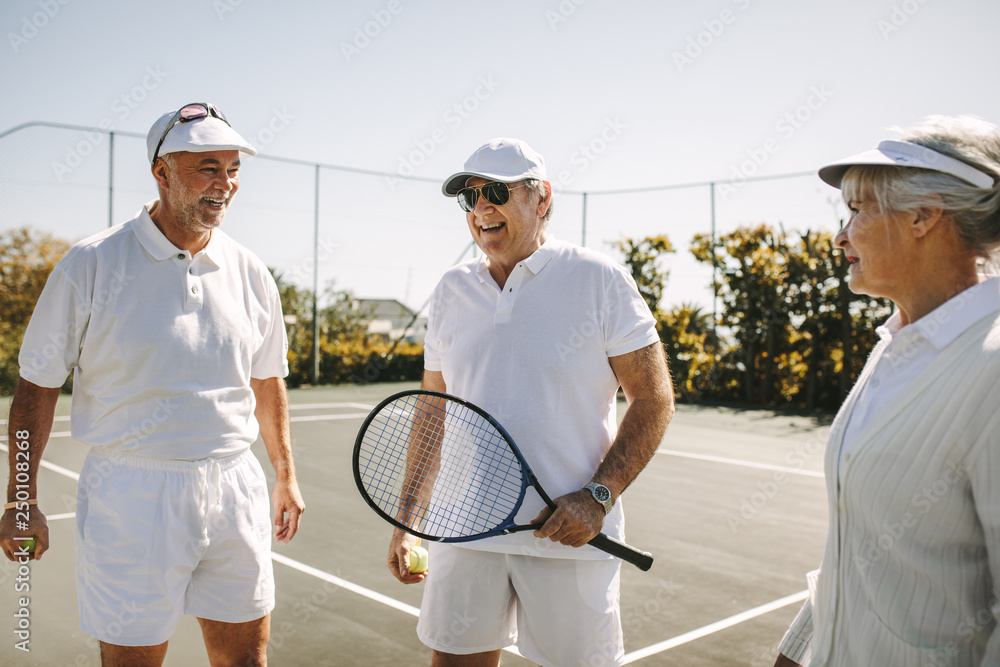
left=0, top=384, right=829, bottom=667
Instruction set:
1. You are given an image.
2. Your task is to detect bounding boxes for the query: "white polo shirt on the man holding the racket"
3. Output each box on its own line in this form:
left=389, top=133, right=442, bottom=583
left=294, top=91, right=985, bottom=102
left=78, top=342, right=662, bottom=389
left=424, top=237, right=659, bottom=559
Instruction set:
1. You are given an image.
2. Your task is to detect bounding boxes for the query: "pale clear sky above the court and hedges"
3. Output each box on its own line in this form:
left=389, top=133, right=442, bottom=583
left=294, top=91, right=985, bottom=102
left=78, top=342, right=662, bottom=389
left=0, top=0, right=1000, bottom=314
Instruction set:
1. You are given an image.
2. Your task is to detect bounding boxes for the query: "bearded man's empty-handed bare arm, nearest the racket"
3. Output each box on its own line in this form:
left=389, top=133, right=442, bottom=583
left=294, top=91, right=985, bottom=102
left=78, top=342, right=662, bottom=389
left=250, top=377, right=306, bottom=544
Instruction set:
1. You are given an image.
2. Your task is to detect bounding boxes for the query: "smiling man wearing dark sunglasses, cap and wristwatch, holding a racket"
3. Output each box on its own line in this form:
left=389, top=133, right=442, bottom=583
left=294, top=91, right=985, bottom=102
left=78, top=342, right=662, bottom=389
left=388, top=139, right=673, bottom=667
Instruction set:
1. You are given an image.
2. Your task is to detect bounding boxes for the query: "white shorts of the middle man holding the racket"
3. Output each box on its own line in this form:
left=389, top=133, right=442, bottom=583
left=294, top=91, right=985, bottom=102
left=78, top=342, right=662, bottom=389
left=417, top=542, right=625, bottom=667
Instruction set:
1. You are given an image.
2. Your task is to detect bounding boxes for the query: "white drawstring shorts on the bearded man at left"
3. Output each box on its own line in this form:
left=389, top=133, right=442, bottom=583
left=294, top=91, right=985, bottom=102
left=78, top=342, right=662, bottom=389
left=76, top=449, right=274, bottom=646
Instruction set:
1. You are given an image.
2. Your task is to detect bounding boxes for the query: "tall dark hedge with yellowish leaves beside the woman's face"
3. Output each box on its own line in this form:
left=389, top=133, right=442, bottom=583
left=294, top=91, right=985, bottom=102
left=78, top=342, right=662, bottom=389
left=691, top=225, right=889, bottom=409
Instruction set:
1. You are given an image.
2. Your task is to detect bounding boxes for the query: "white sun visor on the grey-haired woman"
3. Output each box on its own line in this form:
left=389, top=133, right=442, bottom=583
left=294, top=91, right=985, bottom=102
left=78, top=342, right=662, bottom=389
left=819, top=140, right=996, bottom=189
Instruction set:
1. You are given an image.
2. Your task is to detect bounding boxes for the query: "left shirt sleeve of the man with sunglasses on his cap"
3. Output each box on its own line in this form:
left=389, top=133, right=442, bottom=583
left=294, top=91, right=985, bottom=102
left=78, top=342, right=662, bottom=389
left=18, top=265, right=90, bottom=388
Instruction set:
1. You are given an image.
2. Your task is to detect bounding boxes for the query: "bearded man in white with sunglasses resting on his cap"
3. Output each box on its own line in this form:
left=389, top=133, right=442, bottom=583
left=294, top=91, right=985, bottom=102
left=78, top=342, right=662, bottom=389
left=0, top=103, right=305, bottom=666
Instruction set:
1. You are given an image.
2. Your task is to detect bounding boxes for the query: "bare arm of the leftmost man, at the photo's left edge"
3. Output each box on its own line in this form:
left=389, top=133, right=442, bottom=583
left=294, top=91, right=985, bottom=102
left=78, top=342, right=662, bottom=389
left=0, top=378, right=59, bottom=560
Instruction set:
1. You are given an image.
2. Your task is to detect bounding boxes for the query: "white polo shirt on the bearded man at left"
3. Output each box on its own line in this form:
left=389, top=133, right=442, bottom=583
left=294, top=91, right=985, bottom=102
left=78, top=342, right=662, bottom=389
left=19, top=202, right=288, bottom=461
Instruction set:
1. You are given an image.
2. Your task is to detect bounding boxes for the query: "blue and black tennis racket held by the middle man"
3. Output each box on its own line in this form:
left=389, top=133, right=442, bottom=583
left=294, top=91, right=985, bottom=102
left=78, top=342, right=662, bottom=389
left=354, top=390, right=653, bottom=571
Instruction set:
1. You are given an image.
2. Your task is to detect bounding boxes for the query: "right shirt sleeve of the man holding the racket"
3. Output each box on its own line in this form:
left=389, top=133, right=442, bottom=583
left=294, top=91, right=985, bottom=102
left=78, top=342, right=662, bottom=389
left=604, top=266, right=660, bottom=357
